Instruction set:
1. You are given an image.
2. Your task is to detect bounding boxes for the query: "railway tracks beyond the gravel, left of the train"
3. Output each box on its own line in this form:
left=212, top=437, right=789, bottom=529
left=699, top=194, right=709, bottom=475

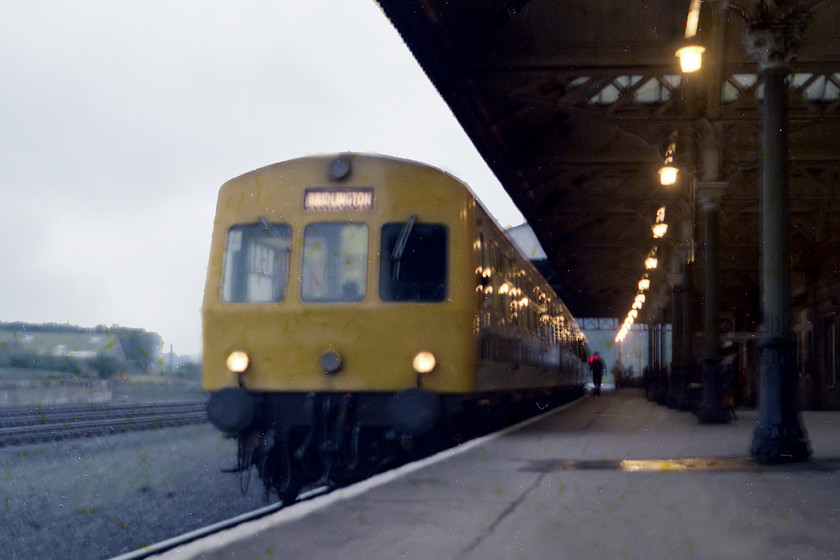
left=0, top=401, right=207, bottom=447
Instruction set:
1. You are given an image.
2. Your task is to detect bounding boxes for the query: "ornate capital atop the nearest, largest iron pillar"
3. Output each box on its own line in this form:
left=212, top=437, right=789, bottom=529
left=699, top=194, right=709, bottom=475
left=744, top=0, right=814, bottom=70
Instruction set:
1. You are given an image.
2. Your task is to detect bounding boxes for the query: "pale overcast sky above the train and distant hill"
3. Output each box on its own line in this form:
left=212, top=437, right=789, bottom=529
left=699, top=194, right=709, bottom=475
left=0, top=0, right=522, bottom=354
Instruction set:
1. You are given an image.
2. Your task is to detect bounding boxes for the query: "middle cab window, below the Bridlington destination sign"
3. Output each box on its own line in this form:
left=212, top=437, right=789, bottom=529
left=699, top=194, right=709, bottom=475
left=301, top=223, right=368, bottom=302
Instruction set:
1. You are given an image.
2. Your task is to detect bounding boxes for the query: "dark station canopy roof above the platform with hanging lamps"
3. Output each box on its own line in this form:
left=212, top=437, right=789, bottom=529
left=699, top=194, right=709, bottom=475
left=380, top=0, right=840, bottom=325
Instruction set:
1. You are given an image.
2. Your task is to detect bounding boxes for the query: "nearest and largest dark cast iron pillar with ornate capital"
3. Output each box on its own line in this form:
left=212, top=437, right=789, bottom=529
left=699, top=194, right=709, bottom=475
left=745, top=1, right=812, bottom=463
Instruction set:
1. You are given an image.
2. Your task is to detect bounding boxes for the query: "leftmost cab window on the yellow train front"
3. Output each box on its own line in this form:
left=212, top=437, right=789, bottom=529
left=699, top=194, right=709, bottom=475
left=222, top=221, right=292, bottom=303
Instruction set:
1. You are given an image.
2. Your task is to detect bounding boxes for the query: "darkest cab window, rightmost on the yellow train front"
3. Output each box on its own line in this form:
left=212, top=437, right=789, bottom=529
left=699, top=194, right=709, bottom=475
left=379, top=222, right=449, bottom=302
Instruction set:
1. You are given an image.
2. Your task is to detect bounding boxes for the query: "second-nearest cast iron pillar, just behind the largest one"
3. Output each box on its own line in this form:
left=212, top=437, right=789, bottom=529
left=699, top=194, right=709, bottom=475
left=696, top=181, right=732, bottom=424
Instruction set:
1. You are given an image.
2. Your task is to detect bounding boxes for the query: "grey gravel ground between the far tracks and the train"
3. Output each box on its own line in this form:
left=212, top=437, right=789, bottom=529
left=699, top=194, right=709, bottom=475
left=0, top=424, right=268, bottom=560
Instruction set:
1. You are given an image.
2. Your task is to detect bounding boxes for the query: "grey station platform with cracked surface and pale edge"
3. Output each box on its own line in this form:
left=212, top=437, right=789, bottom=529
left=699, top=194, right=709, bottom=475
left=156, top=390, right=840, bottom=560
